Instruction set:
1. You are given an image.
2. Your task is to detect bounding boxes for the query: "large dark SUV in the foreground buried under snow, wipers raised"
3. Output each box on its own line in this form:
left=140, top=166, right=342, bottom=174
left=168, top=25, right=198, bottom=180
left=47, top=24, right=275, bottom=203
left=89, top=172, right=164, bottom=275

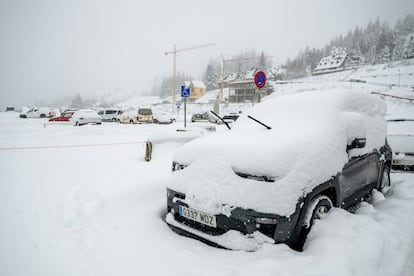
left=166, top=90, right=392, bottom=251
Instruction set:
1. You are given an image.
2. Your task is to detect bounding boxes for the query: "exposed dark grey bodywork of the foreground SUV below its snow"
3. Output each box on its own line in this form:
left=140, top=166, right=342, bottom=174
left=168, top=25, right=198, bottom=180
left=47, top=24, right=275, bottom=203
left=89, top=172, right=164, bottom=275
left=167, top=143, right=392, bottom=249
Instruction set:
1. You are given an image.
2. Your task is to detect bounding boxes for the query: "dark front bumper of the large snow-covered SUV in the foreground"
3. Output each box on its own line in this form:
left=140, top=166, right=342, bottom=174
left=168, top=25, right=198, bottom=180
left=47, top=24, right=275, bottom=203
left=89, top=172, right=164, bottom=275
left=166, top=189, right=299, bottom=251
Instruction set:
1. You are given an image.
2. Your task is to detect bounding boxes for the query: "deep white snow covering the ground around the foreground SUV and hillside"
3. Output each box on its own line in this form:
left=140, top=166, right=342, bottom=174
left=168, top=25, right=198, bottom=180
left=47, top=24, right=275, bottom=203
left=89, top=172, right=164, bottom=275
left=0, top=61, right=414, bottom=276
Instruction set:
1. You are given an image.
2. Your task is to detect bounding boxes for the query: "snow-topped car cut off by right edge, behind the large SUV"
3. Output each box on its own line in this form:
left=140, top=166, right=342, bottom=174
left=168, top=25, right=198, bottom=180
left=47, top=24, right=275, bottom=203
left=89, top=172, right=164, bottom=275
left=387, top=116, right=414, bottom=171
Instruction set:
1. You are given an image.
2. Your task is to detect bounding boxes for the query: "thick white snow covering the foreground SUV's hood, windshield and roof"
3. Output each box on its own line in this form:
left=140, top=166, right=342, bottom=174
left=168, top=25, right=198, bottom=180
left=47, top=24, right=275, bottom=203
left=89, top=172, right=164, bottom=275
left=167, top=90, right=386, bottom=216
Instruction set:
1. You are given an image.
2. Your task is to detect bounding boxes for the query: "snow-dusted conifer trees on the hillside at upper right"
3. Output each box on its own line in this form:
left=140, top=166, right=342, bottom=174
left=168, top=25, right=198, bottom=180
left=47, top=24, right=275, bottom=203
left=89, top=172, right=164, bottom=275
left=282, top=15, right=414, bottom=78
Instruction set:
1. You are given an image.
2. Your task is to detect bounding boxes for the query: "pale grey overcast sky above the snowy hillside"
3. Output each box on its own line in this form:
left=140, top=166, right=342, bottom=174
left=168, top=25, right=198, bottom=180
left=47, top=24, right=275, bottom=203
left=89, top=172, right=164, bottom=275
left=0, top=0, right=414, bottom=108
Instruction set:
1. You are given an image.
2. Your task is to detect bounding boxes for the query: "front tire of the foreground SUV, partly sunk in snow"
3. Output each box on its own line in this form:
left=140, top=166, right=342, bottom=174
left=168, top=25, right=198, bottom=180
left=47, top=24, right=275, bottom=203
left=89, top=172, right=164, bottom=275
left=293, top=195, right=333, bottom=251
